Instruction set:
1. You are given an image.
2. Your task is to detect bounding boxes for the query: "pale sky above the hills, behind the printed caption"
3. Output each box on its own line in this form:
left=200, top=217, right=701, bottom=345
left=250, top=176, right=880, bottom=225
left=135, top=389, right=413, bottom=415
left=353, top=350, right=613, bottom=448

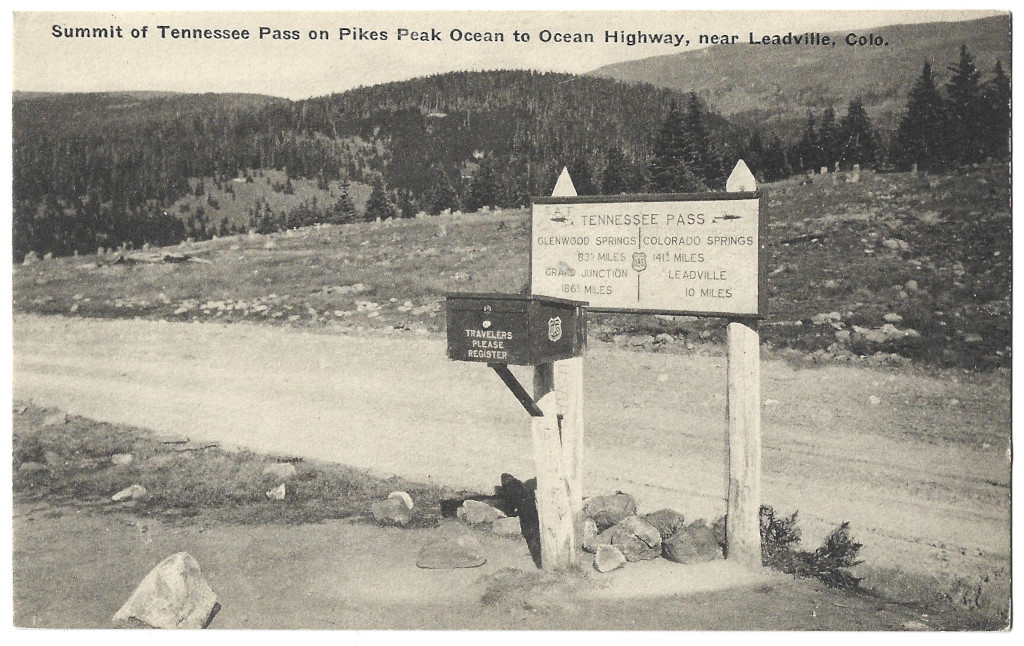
left=11, top=0, right=992, bottom=99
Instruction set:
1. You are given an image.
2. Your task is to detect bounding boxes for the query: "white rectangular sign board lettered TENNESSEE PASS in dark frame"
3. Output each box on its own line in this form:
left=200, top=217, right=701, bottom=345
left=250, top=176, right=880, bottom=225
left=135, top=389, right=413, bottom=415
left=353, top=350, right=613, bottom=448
left=530, top=191, right=766, bottom=317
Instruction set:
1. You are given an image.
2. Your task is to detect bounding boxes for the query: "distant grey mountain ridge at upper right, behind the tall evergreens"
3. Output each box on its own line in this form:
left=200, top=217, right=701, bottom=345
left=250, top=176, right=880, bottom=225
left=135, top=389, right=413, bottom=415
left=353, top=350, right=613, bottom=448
left=587, top=13, right=1012, bottom=138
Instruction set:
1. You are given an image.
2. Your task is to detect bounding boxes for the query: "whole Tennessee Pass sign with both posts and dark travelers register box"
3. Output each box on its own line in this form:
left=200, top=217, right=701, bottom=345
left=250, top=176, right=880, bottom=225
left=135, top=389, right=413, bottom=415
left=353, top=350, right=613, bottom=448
left=446, top=161, right=766, bottom=569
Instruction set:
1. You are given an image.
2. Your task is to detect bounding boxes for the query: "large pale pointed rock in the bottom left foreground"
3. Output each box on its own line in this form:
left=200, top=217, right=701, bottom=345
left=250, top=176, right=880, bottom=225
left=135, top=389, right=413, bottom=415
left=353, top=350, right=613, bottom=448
left=114, top=552, right=220, bottom=629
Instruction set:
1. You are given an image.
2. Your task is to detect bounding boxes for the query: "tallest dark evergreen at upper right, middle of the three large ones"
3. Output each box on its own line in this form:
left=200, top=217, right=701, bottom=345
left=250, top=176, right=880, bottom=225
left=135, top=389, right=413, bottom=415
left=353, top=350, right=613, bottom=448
left=946, top=45, right=984, bottom=164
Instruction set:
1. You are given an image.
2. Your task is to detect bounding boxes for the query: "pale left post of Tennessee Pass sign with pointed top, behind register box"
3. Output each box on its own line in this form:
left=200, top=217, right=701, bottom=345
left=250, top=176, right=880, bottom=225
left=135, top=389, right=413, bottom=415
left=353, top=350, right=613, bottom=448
left=532, top=169, right=584, bottom=570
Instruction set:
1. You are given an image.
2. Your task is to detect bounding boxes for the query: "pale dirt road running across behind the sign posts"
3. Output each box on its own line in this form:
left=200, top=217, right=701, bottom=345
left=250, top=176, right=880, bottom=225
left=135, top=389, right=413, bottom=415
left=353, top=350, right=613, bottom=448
left=13, top=315, right=1011, bottom=605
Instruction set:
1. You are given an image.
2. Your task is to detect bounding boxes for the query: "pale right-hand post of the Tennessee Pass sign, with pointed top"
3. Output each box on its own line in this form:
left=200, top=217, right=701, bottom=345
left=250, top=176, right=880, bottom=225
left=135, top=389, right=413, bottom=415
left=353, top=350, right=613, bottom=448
left=726, top=161, right=764, bottom=569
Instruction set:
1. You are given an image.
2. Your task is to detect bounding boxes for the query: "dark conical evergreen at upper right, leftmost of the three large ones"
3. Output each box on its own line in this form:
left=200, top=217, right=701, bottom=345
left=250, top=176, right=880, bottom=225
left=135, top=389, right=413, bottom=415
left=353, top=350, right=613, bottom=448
left=892, top=62, right=949, bottom=171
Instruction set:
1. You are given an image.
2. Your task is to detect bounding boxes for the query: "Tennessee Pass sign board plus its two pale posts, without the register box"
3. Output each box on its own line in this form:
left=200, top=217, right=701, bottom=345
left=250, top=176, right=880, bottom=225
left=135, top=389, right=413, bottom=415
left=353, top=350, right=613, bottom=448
left=530, top=161, right=766, bottom=568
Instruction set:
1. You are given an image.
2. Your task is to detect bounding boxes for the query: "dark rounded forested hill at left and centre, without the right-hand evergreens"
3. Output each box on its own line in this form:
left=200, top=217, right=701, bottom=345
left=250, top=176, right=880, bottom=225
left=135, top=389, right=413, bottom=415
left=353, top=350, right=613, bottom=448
left=13, top=71, right=739, bottom=257
